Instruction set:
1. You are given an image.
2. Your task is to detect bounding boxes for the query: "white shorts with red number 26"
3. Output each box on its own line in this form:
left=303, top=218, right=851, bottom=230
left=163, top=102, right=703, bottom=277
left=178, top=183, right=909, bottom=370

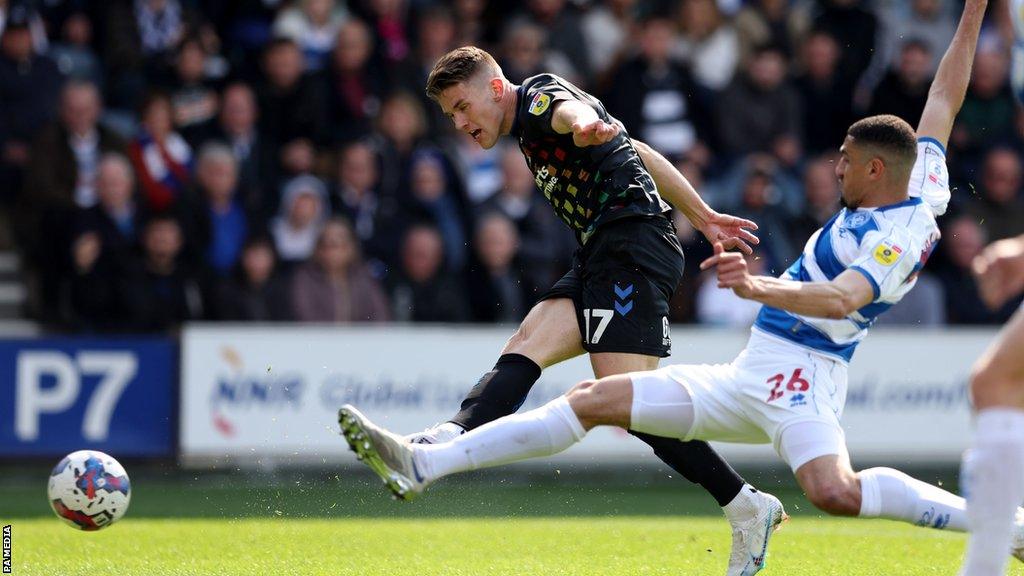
left=630, top=330, right=847, bottom=470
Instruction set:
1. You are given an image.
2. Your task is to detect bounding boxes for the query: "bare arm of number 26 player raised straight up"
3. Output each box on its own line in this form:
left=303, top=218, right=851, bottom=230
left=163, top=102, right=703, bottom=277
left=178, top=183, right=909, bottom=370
left=918, top=0, right=988, bottom=147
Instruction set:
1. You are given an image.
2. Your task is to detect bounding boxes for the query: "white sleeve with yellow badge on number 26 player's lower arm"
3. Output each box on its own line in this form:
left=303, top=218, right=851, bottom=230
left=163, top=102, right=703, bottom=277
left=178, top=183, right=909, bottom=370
left=850, top=227, right=921, bottom=301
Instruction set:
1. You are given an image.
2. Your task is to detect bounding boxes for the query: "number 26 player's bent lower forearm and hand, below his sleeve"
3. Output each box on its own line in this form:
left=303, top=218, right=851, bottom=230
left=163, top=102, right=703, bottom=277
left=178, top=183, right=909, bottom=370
left=700, top=242, right=874, bottom=320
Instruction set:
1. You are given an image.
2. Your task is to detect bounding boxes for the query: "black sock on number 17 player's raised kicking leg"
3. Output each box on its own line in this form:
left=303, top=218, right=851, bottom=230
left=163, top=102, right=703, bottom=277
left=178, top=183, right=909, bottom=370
left=450, top=354, right=544, bottom=428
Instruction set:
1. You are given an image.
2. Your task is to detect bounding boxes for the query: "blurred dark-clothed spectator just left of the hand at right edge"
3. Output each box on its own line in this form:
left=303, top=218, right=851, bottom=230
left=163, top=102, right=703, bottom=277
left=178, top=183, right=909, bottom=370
left=940, top=216, right=1020, bottom=324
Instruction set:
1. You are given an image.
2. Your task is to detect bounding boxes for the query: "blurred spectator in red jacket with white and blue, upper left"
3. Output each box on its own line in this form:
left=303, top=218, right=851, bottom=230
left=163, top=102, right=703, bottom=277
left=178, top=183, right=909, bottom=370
left=128, top=92, right=193, bottom=211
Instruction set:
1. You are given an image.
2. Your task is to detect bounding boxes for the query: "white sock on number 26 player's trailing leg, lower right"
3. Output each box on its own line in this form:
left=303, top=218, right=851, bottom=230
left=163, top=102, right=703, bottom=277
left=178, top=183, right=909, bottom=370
left=857, top=468, right=967, bottom=532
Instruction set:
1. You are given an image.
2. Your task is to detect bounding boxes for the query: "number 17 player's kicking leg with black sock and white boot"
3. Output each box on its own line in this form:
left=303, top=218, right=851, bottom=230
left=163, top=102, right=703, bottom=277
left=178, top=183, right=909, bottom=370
left=407, top=295, right=584, bottom=444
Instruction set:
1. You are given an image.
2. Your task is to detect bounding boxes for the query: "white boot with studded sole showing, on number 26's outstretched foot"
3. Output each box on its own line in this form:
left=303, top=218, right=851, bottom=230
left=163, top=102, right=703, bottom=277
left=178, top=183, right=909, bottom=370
left=338, top=404, right=429, bottom=500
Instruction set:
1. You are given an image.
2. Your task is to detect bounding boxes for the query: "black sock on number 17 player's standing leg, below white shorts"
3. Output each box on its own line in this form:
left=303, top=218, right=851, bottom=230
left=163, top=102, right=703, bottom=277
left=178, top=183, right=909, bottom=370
left=630, top=430, right=744, bottom=506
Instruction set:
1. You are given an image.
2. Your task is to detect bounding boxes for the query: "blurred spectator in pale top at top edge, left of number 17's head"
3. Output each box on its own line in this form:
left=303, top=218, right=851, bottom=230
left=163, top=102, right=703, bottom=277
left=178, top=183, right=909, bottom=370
left=273, top=0, right=345, bottom=71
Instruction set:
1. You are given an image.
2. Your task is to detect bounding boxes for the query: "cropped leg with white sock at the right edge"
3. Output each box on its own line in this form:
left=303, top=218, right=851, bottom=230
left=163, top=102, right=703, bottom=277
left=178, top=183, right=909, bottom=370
left=961, top=303, right=1024, bottom=576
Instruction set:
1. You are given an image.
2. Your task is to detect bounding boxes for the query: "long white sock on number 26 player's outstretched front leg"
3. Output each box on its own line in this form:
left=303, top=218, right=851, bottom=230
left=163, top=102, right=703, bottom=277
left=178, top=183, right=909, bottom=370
left=416, top=396, right=587, bottom=481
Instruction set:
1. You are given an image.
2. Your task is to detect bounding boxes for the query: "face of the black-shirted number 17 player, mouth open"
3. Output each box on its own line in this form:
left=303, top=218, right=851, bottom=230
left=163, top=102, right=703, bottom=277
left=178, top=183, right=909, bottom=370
left=437, top=76, right=505, bottom=149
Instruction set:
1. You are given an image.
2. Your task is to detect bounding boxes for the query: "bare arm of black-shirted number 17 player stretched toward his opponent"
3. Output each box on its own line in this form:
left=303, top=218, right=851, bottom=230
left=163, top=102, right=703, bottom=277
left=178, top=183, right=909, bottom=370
left=633, top=139, right=760, bottom=254
